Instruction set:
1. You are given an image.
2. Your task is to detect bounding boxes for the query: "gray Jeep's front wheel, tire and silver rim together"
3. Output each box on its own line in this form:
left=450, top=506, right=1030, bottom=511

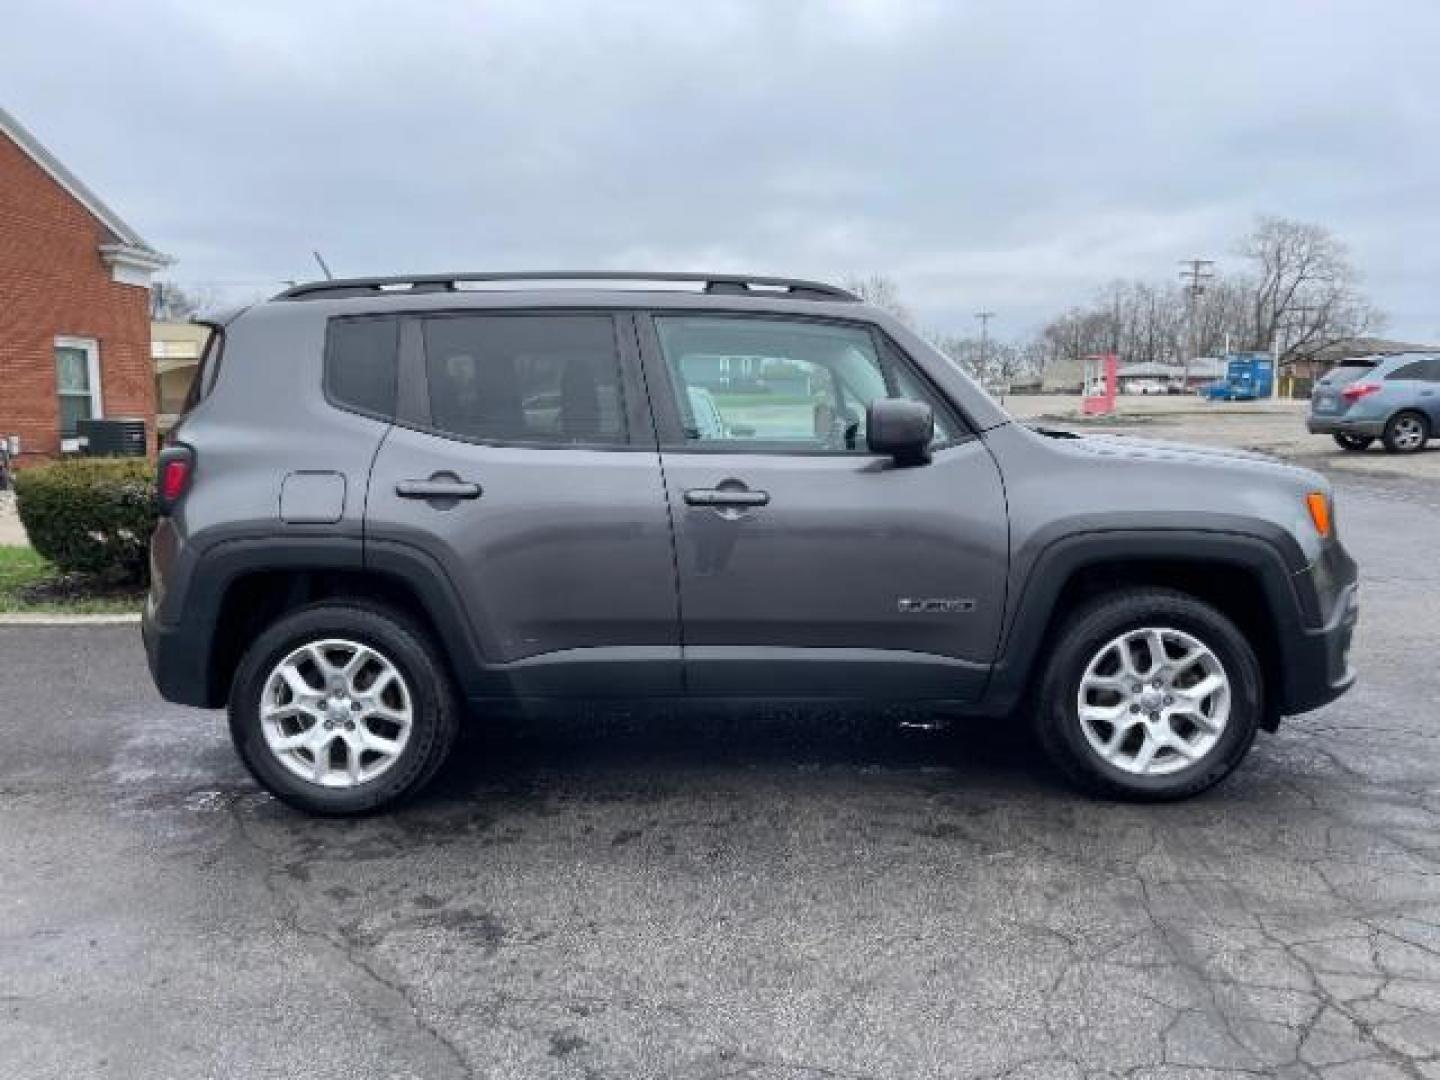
left=1037, top=589, right=1261, bottom=801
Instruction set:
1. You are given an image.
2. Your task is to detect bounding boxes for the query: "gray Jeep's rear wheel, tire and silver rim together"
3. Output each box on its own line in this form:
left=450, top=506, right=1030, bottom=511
left=230, top=603, right=456, bottom=815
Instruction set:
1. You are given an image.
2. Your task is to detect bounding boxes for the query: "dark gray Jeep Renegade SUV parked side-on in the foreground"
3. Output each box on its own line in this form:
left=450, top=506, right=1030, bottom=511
left=144, top=274, right=1356, bottom=814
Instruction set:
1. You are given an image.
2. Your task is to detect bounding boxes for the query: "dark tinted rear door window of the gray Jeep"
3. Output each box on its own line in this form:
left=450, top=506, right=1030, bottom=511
left=425, top=315, right=625, bottom=444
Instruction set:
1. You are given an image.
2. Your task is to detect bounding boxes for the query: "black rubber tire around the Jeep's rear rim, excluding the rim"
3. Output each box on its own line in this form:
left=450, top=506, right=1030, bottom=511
left=229, top=602, right=459, bottom=816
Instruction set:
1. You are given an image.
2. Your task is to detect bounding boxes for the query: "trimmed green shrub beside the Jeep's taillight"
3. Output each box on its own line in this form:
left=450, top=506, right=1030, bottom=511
left=14, top=458, right=156, bottom=582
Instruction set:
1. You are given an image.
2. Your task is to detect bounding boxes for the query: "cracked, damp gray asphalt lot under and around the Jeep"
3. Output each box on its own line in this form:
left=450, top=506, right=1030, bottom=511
left=0, top=443, right=1440, bottom=1080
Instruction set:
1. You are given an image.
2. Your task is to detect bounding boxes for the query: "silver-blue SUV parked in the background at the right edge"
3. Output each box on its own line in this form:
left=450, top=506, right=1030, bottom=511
left=1306, top=353, right=1440, bottom=454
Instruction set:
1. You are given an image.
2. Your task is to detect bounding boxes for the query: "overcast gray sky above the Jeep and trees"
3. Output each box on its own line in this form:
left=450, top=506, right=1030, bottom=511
left=0, top=0, right=1440, bottom=341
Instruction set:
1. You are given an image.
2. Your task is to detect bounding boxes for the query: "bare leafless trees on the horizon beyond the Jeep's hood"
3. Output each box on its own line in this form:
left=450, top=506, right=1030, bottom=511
left=848, top=216, right=1385, bottom=384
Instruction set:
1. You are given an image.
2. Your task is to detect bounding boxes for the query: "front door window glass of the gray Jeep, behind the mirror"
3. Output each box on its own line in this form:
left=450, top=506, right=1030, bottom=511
left=655, top=315, right=956, bottom=454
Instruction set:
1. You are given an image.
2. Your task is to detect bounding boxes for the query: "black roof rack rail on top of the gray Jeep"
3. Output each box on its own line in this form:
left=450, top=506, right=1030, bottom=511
left=275, top=271, right=860, bottom=301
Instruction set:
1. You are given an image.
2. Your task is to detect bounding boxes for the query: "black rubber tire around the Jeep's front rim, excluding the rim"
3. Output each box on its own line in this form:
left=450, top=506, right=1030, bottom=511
left=1035, top=588, right=1263, bottom=802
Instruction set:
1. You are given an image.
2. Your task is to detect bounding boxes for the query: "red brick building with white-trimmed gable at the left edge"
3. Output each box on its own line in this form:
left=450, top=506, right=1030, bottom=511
left=0, top=109, right=170, bottom=465
